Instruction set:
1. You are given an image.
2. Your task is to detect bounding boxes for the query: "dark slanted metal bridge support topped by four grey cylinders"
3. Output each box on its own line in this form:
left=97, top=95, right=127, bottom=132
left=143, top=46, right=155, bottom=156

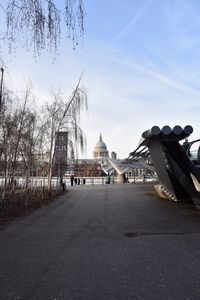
left=140, top=125, right=200, bottom=205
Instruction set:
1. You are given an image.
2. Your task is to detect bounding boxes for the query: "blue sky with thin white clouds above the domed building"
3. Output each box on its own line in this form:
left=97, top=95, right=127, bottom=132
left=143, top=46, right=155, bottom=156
left=0, top=0, right=200, bottom=158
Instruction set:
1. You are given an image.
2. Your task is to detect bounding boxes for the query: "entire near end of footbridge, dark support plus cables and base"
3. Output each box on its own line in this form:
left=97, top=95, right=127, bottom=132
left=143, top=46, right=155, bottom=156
left=127, top=125, right=200, bottom=206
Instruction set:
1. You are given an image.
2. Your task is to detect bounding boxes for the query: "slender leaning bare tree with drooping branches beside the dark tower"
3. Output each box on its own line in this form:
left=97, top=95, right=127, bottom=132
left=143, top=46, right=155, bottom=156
left=43, top=75, right=87, bottom=191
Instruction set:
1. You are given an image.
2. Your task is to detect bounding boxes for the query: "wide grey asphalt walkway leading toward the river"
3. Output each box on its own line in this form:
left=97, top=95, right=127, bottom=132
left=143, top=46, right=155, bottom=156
left=0, top=184, right=200, bottom=300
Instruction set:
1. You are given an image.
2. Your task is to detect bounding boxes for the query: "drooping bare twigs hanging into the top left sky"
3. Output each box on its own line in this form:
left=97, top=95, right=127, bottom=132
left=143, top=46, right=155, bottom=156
left=0, top=0, right=85, bottom=56
